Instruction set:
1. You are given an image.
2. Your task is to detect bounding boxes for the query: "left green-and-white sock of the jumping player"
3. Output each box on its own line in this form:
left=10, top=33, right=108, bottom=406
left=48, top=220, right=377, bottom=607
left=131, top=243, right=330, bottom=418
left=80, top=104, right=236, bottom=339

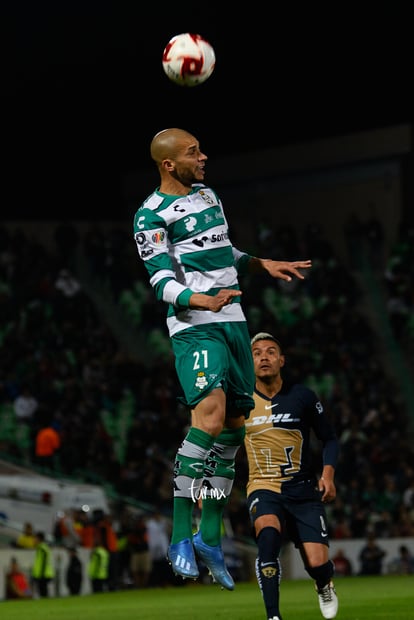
left=171, top=428, right=214, bottom=544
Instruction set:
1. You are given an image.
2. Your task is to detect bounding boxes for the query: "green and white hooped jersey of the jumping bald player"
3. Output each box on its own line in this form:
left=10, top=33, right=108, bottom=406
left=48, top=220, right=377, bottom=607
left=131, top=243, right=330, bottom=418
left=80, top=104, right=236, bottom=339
left=134, top=184, right=250, bottom=336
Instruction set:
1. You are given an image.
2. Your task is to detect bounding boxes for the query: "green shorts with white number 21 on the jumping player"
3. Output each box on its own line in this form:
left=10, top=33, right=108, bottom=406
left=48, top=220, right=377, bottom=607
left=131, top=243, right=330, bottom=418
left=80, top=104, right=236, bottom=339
left=171, top=322, right=255, bottom=418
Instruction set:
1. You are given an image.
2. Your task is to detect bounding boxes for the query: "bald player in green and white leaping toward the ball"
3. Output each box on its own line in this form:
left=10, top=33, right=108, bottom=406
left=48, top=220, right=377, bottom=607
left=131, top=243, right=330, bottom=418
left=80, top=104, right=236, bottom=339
left=134, top=128, right=311, bottom=590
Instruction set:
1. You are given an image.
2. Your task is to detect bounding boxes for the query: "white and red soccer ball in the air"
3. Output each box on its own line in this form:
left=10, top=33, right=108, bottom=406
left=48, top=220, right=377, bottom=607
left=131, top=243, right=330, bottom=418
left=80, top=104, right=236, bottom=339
left=162, top=32, right=216, bottom=86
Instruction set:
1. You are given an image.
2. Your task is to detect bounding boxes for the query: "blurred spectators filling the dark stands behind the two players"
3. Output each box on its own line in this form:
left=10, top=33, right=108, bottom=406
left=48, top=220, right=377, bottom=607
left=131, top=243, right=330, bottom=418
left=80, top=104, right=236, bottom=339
left=0, top=218, right=414, bottom=539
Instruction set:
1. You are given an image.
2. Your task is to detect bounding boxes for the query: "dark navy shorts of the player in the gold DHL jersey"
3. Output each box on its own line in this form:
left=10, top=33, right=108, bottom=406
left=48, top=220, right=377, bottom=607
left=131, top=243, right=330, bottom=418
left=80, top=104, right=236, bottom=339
left=247, top=483, right=329, bottom=547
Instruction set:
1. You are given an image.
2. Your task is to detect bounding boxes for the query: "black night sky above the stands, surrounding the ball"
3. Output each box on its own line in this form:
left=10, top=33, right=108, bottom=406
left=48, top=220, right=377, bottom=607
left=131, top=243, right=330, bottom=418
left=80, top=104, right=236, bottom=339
left=4, top=0, right=414, bottom=219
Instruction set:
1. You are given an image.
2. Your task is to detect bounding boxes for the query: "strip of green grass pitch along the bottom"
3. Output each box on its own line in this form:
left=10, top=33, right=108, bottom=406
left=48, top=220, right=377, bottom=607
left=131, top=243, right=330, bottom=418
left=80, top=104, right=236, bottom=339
left=0, top=575, right=414, bottom=620
